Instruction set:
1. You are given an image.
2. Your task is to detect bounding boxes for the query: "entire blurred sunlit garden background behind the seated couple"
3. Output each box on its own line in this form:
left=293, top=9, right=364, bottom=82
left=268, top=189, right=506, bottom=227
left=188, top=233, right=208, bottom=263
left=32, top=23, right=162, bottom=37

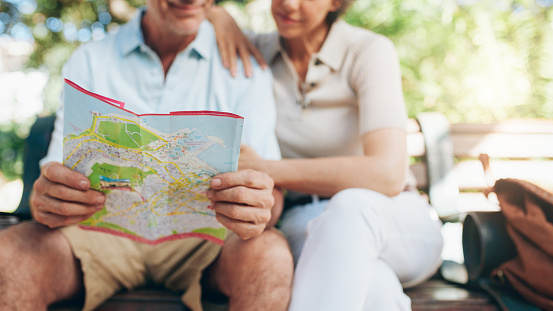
left=0, top=0, right=553, bottom=210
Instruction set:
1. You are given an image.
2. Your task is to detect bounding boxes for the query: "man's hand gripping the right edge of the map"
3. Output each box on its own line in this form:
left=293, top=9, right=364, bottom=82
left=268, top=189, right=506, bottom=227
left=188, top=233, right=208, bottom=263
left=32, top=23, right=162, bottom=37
left=207, top=170, right=275, bottom=240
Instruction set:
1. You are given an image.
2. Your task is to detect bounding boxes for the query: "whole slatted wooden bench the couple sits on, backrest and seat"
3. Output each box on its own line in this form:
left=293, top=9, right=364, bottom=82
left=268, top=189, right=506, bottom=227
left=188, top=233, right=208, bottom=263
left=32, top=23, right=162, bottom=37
left=2, top=113, right=553, bottom=311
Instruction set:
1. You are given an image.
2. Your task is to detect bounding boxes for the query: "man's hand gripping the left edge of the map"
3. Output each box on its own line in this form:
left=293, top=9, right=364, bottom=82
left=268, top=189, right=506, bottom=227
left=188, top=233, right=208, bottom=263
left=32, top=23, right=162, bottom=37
left=30, top=162, right=106, bottom=228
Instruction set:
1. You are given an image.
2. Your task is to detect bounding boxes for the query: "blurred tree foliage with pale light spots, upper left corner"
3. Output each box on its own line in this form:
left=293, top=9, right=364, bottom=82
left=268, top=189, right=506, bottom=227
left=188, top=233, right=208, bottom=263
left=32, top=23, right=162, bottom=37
left=0, top=0, right=143, bottom=111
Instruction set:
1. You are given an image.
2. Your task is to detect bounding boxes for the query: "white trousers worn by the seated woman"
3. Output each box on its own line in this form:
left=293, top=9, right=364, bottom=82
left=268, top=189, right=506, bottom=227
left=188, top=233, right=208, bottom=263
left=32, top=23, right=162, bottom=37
left=280, top=189, right=443, bottom=311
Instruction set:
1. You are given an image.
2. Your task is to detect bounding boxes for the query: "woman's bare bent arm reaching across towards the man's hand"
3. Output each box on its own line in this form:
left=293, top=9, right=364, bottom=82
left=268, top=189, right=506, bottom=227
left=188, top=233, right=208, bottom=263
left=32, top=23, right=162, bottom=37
left=239, top=129, right=407, bottom=196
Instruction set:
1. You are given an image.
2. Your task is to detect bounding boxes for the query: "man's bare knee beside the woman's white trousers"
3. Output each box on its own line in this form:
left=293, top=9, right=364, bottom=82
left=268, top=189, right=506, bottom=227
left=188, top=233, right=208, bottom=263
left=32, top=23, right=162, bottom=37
left=206, top=230, right=294, bottom=311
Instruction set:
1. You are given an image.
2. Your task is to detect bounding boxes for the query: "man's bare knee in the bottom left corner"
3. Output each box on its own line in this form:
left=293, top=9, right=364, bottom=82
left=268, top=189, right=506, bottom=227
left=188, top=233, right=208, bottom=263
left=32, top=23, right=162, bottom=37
left=0, top=223, right=83, bottom=311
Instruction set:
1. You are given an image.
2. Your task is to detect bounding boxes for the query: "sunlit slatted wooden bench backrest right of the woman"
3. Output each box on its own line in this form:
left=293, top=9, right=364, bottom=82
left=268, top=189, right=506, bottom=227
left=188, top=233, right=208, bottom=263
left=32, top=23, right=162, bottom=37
left=408, top=113, right=553, bottom=217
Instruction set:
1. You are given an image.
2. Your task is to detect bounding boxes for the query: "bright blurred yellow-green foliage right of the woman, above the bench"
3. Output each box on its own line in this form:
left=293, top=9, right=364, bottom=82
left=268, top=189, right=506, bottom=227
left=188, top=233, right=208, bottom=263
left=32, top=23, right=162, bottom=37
left=345, top=0, right=553, bottom=122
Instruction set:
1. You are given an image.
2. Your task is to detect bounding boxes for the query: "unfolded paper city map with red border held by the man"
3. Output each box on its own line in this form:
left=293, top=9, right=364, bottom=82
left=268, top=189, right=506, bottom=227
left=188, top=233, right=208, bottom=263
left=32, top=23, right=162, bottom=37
left=63, top=80, right=244, bottom=245
